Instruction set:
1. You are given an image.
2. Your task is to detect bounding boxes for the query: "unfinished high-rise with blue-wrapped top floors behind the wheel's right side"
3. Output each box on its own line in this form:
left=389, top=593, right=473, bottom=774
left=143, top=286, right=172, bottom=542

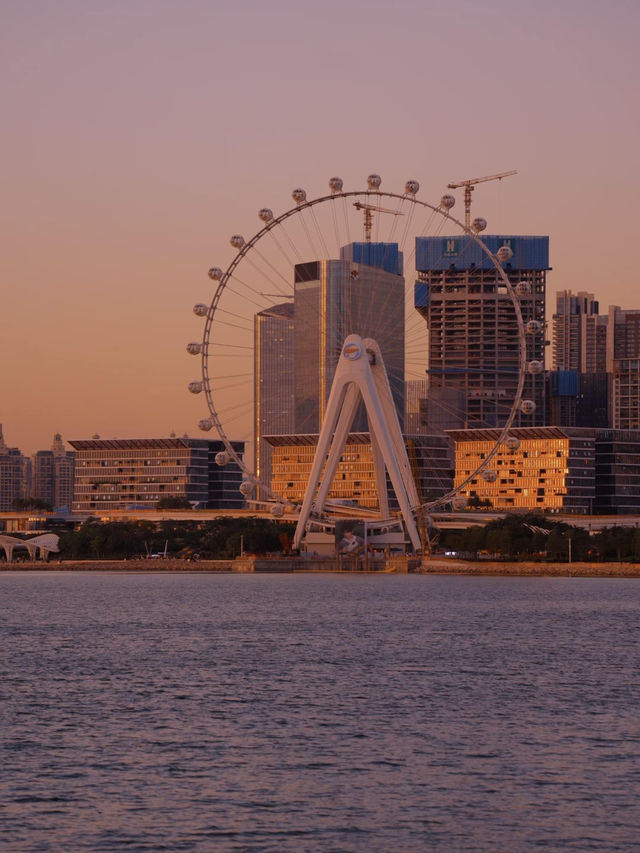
left=415, top=235, right=549, bottom=432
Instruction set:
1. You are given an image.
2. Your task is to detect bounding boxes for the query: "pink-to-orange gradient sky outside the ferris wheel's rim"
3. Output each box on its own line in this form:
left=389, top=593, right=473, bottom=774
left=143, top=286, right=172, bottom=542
left=0, top=0, right=640, bottom=453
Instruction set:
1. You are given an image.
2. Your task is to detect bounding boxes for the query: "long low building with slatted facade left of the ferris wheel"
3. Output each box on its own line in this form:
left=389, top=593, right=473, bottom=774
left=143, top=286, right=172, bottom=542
left=69, top=437, right=244, bottom=513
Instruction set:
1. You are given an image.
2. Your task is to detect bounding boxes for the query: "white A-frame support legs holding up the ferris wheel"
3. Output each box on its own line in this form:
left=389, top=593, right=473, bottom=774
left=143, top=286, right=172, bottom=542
left=293, top=335, right=421, bottom=550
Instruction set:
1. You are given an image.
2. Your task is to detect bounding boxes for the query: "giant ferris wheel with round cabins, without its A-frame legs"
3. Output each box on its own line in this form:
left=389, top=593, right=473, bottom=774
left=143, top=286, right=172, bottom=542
left=187, top=174, right=543, bottom=540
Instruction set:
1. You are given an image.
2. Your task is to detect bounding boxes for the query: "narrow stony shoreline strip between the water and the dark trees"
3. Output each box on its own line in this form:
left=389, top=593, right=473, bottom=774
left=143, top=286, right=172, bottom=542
left=0, top=558, right=640, bottom=578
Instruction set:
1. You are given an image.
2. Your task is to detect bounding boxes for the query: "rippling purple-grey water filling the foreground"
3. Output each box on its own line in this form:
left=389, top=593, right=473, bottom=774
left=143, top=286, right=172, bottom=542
left=0, top=573, right=640, bottom=853
